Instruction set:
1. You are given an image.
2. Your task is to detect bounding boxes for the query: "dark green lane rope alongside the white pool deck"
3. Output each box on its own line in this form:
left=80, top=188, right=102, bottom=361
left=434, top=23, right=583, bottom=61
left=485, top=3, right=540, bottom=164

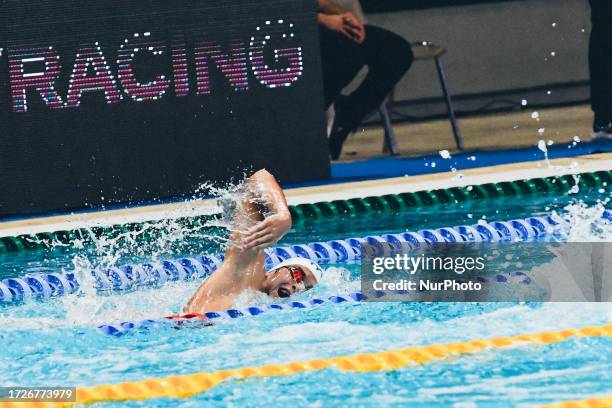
left=0, top=171, right=612, bottom=254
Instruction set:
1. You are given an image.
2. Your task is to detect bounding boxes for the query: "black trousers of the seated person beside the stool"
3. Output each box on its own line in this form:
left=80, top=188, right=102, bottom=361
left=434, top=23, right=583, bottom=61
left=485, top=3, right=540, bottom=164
left=320, top=25, right=413, bottom=128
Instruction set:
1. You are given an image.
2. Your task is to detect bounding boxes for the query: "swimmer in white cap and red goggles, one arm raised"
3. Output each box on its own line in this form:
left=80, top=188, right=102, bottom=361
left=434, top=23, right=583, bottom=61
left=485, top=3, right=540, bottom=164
left=183, top=170, right=323, bottom=314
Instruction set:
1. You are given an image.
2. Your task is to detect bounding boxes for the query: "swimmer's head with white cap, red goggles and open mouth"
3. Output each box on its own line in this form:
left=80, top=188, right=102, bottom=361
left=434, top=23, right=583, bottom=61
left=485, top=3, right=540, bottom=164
left=262, top=258, right=323, bottom=298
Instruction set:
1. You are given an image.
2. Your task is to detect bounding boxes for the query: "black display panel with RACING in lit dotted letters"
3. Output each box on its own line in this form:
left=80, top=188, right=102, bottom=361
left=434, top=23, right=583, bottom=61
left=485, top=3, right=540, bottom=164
left=0, top=0, right=329, bottom=217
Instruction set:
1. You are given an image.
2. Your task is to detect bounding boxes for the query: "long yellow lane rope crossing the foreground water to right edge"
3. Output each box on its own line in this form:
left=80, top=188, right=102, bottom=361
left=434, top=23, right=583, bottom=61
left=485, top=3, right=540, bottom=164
left=0, top=324, right=612, bottom=408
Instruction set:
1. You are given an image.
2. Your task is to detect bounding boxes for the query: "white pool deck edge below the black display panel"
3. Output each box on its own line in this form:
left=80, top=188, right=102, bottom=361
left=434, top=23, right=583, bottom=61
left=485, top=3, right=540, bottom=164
left=0, top=153, right=612, bottom=237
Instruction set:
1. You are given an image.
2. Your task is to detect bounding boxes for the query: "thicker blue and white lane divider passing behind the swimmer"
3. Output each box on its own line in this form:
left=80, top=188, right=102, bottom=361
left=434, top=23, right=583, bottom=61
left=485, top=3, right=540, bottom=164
left=0, top=210, right=612, bottom=302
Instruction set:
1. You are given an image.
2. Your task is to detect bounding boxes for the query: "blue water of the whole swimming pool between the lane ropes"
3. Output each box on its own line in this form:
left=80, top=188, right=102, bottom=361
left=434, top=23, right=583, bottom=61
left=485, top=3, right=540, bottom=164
left=0, top=171, right=612, bottom=407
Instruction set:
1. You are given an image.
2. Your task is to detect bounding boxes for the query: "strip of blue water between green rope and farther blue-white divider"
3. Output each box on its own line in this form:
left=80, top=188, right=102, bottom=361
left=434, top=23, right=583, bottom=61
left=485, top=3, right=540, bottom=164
left=0, top=186, right=612, bottom=279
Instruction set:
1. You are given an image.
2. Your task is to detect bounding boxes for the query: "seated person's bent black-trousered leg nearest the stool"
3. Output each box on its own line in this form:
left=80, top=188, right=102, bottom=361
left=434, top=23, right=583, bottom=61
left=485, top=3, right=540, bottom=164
left=329, top=25, right=413, bottom=159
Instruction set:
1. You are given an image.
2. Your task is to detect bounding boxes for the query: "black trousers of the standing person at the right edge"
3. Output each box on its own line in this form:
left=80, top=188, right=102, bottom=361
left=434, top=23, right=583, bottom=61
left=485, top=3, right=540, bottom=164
left=589, top=0, right=612, bottom=120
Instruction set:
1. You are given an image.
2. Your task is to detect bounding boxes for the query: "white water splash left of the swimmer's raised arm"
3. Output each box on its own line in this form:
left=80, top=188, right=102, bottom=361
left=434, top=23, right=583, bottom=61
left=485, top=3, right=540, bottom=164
left=61, top=180, right=266, bottom=325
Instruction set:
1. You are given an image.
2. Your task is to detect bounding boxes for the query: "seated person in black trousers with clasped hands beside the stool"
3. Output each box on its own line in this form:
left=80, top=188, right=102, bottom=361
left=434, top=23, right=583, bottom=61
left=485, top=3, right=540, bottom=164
left=318, top=0, right=413, bottom=160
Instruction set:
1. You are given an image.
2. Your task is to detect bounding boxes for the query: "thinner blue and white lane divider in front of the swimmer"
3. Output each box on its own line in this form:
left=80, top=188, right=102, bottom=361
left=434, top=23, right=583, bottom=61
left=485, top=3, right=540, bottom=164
left=98, top=271, right=532, bottom=336
